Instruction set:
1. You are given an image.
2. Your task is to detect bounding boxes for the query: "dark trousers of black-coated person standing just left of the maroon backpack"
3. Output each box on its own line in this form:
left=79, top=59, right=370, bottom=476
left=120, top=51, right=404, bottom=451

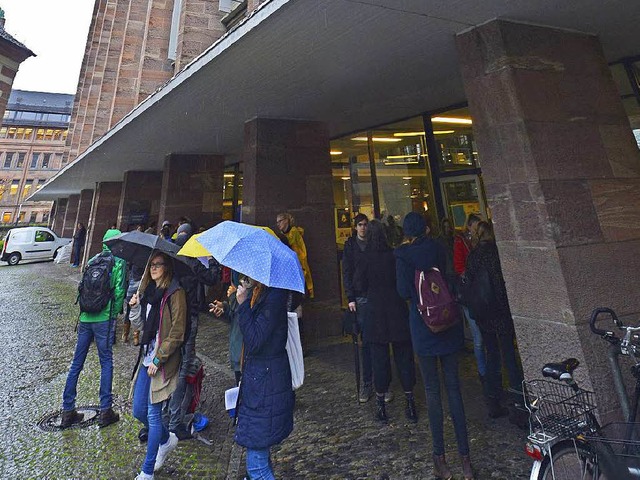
left=370, top=341, right=416, bottom=393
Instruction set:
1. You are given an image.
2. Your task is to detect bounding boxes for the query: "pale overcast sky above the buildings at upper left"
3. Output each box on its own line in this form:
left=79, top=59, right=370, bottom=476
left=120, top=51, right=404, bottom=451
left=0, top=0, right=94, bottom=94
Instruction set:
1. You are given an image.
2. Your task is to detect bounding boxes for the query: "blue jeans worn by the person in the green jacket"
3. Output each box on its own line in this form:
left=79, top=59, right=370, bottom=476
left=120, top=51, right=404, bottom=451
left=62, top=320, right=114, bottom=411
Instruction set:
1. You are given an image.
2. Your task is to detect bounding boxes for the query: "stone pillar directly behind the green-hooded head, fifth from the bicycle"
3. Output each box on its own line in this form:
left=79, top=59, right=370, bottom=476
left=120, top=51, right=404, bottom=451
left=82, top=182, right=122, bottom=265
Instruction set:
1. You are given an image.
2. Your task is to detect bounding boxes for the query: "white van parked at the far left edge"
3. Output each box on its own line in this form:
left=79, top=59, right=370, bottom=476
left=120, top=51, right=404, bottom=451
left=0, top=227, right=71, bottom=265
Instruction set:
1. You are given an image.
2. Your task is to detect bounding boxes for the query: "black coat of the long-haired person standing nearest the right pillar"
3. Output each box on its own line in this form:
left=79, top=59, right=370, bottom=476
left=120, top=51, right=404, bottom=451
left=465, top=241, right=514, bottom=334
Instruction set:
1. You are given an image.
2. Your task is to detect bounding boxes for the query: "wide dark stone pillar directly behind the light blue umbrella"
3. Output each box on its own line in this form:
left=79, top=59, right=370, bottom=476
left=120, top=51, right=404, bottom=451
left=242, top=118, right=341, bottom=340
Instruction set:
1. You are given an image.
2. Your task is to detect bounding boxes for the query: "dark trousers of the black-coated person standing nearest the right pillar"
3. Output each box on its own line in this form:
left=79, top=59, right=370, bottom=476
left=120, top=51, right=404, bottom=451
left=482, top=332, right=523, bottom=398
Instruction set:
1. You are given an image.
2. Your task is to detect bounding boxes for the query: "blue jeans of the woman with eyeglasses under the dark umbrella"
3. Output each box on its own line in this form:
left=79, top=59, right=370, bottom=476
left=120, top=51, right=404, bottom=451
left=133, top=366, right=169, bottom=475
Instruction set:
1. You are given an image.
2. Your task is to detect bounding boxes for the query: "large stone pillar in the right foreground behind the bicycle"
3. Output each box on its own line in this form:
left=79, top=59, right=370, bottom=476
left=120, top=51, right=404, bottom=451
left=457, top=20, right=640, bottom=419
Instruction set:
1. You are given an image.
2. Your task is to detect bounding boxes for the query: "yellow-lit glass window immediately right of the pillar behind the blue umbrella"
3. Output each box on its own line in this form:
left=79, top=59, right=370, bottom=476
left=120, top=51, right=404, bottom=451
left=331, top=117, right=437, bottom=245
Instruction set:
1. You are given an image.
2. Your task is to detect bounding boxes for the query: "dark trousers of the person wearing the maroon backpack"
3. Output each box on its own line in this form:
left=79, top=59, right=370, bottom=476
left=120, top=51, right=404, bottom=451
left=418, top=353, right=469, bottom=455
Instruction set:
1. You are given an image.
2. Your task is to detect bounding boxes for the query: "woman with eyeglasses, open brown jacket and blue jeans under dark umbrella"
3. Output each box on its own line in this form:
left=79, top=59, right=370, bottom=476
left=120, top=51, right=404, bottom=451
left=129, top=253, right=187, bottom=480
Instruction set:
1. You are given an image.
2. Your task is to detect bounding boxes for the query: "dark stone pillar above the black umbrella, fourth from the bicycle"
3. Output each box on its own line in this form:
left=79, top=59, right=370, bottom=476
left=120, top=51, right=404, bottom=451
left=118, top=170, right=163, bottom=230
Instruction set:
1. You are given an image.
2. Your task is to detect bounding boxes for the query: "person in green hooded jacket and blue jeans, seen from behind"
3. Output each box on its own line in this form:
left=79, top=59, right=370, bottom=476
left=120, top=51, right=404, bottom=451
left=60, top=228, right=126, bottom=428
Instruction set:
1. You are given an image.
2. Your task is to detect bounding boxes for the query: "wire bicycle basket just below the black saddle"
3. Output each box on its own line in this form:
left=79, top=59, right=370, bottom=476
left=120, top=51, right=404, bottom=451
left=523, top=380, right=596, bottom=437
